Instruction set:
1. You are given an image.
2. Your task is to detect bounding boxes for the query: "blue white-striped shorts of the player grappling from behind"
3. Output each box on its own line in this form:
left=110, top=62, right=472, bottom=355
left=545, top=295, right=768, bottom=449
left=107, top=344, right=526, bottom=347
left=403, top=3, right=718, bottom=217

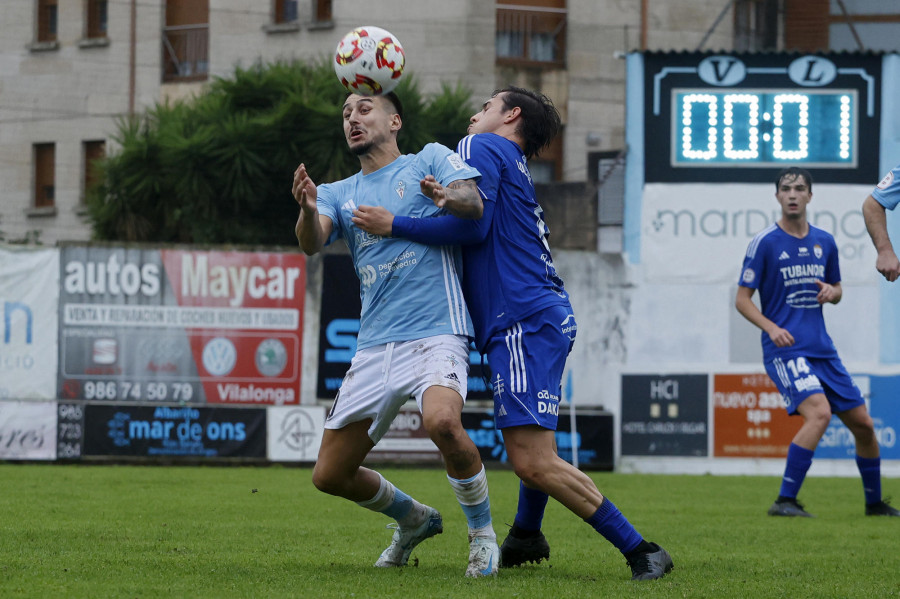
left=486, top=306, right=577, bottom=430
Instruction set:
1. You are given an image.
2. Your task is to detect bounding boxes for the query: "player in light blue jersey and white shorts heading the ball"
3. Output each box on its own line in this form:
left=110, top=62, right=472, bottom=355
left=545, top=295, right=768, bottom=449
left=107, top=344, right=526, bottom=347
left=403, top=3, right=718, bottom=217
left=292, top=94, right=500, bottom=577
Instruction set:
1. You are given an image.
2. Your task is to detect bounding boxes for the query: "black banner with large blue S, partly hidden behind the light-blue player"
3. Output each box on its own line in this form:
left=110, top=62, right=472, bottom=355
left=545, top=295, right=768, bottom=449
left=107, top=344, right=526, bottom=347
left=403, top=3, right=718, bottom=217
left=316, top=255, right=493, bottom=399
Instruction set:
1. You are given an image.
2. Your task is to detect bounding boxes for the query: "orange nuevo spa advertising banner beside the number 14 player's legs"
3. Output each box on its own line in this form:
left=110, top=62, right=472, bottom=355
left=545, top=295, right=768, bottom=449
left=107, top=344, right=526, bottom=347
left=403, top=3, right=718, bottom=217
left=713, top=373, right=803, bottom=458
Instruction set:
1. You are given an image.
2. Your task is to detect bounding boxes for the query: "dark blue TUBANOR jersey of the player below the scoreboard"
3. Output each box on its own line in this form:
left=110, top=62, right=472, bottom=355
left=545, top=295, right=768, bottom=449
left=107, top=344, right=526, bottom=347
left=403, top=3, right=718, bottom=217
left=738, top=224, right=841, bottom=362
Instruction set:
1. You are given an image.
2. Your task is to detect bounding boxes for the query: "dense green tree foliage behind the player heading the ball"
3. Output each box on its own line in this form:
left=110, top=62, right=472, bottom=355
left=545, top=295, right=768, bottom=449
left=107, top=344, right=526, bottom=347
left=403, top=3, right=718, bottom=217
left=87, top=62, right=472, bottom=245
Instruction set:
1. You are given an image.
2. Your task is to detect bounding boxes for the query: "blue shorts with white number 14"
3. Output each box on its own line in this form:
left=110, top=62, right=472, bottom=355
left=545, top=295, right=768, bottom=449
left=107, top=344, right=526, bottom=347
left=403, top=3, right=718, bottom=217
left=766, top=356, right=866, bottom=416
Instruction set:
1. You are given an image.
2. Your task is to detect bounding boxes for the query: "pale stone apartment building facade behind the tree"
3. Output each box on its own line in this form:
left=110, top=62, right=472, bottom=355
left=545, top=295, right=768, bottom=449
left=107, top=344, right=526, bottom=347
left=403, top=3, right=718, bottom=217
left=0, top=0, right=900, bottom=245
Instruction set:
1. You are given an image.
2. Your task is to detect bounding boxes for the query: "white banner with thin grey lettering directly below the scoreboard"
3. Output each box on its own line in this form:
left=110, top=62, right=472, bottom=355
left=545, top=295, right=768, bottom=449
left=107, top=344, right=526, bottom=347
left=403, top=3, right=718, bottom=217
left=641, top=183, right=878, bottom=284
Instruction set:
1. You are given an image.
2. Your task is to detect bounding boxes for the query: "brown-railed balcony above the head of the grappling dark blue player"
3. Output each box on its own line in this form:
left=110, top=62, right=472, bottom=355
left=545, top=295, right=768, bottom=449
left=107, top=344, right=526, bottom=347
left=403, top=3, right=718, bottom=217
left=496, top=5, right=566, bottom=66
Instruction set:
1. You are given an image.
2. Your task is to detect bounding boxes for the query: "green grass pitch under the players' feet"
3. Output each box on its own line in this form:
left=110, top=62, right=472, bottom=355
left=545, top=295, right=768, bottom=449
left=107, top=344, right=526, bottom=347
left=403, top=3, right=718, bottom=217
left=0, top=464, right=900, bottom=599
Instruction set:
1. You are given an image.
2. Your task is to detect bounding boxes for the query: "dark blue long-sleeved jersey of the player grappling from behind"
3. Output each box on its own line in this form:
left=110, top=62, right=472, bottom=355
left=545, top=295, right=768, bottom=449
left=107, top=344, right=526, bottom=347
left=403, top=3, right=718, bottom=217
left=393, top=133, right=571, bottom=350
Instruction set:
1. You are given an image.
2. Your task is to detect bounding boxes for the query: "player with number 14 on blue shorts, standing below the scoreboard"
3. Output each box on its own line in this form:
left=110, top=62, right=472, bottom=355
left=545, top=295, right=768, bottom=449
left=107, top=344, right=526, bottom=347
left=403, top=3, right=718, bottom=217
left=735, top=167, right=900, bottom=517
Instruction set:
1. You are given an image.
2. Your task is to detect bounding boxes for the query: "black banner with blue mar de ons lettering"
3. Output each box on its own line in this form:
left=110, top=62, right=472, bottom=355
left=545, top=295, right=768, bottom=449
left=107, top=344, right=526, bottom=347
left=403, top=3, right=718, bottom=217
left=82, top=404, right=266, bottom=458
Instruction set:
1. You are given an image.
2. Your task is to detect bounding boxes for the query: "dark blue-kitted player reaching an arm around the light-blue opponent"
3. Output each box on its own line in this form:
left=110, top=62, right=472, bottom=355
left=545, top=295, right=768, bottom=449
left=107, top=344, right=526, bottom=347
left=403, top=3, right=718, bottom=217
left=353, top=87, right=672, bottom=580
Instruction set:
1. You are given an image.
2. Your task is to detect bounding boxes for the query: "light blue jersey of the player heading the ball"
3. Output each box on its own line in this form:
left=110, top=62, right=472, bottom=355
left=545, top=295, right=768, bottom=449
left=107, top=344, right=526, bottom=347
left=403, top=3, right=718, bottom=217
left=316, top=144, right=479, bottom=349
